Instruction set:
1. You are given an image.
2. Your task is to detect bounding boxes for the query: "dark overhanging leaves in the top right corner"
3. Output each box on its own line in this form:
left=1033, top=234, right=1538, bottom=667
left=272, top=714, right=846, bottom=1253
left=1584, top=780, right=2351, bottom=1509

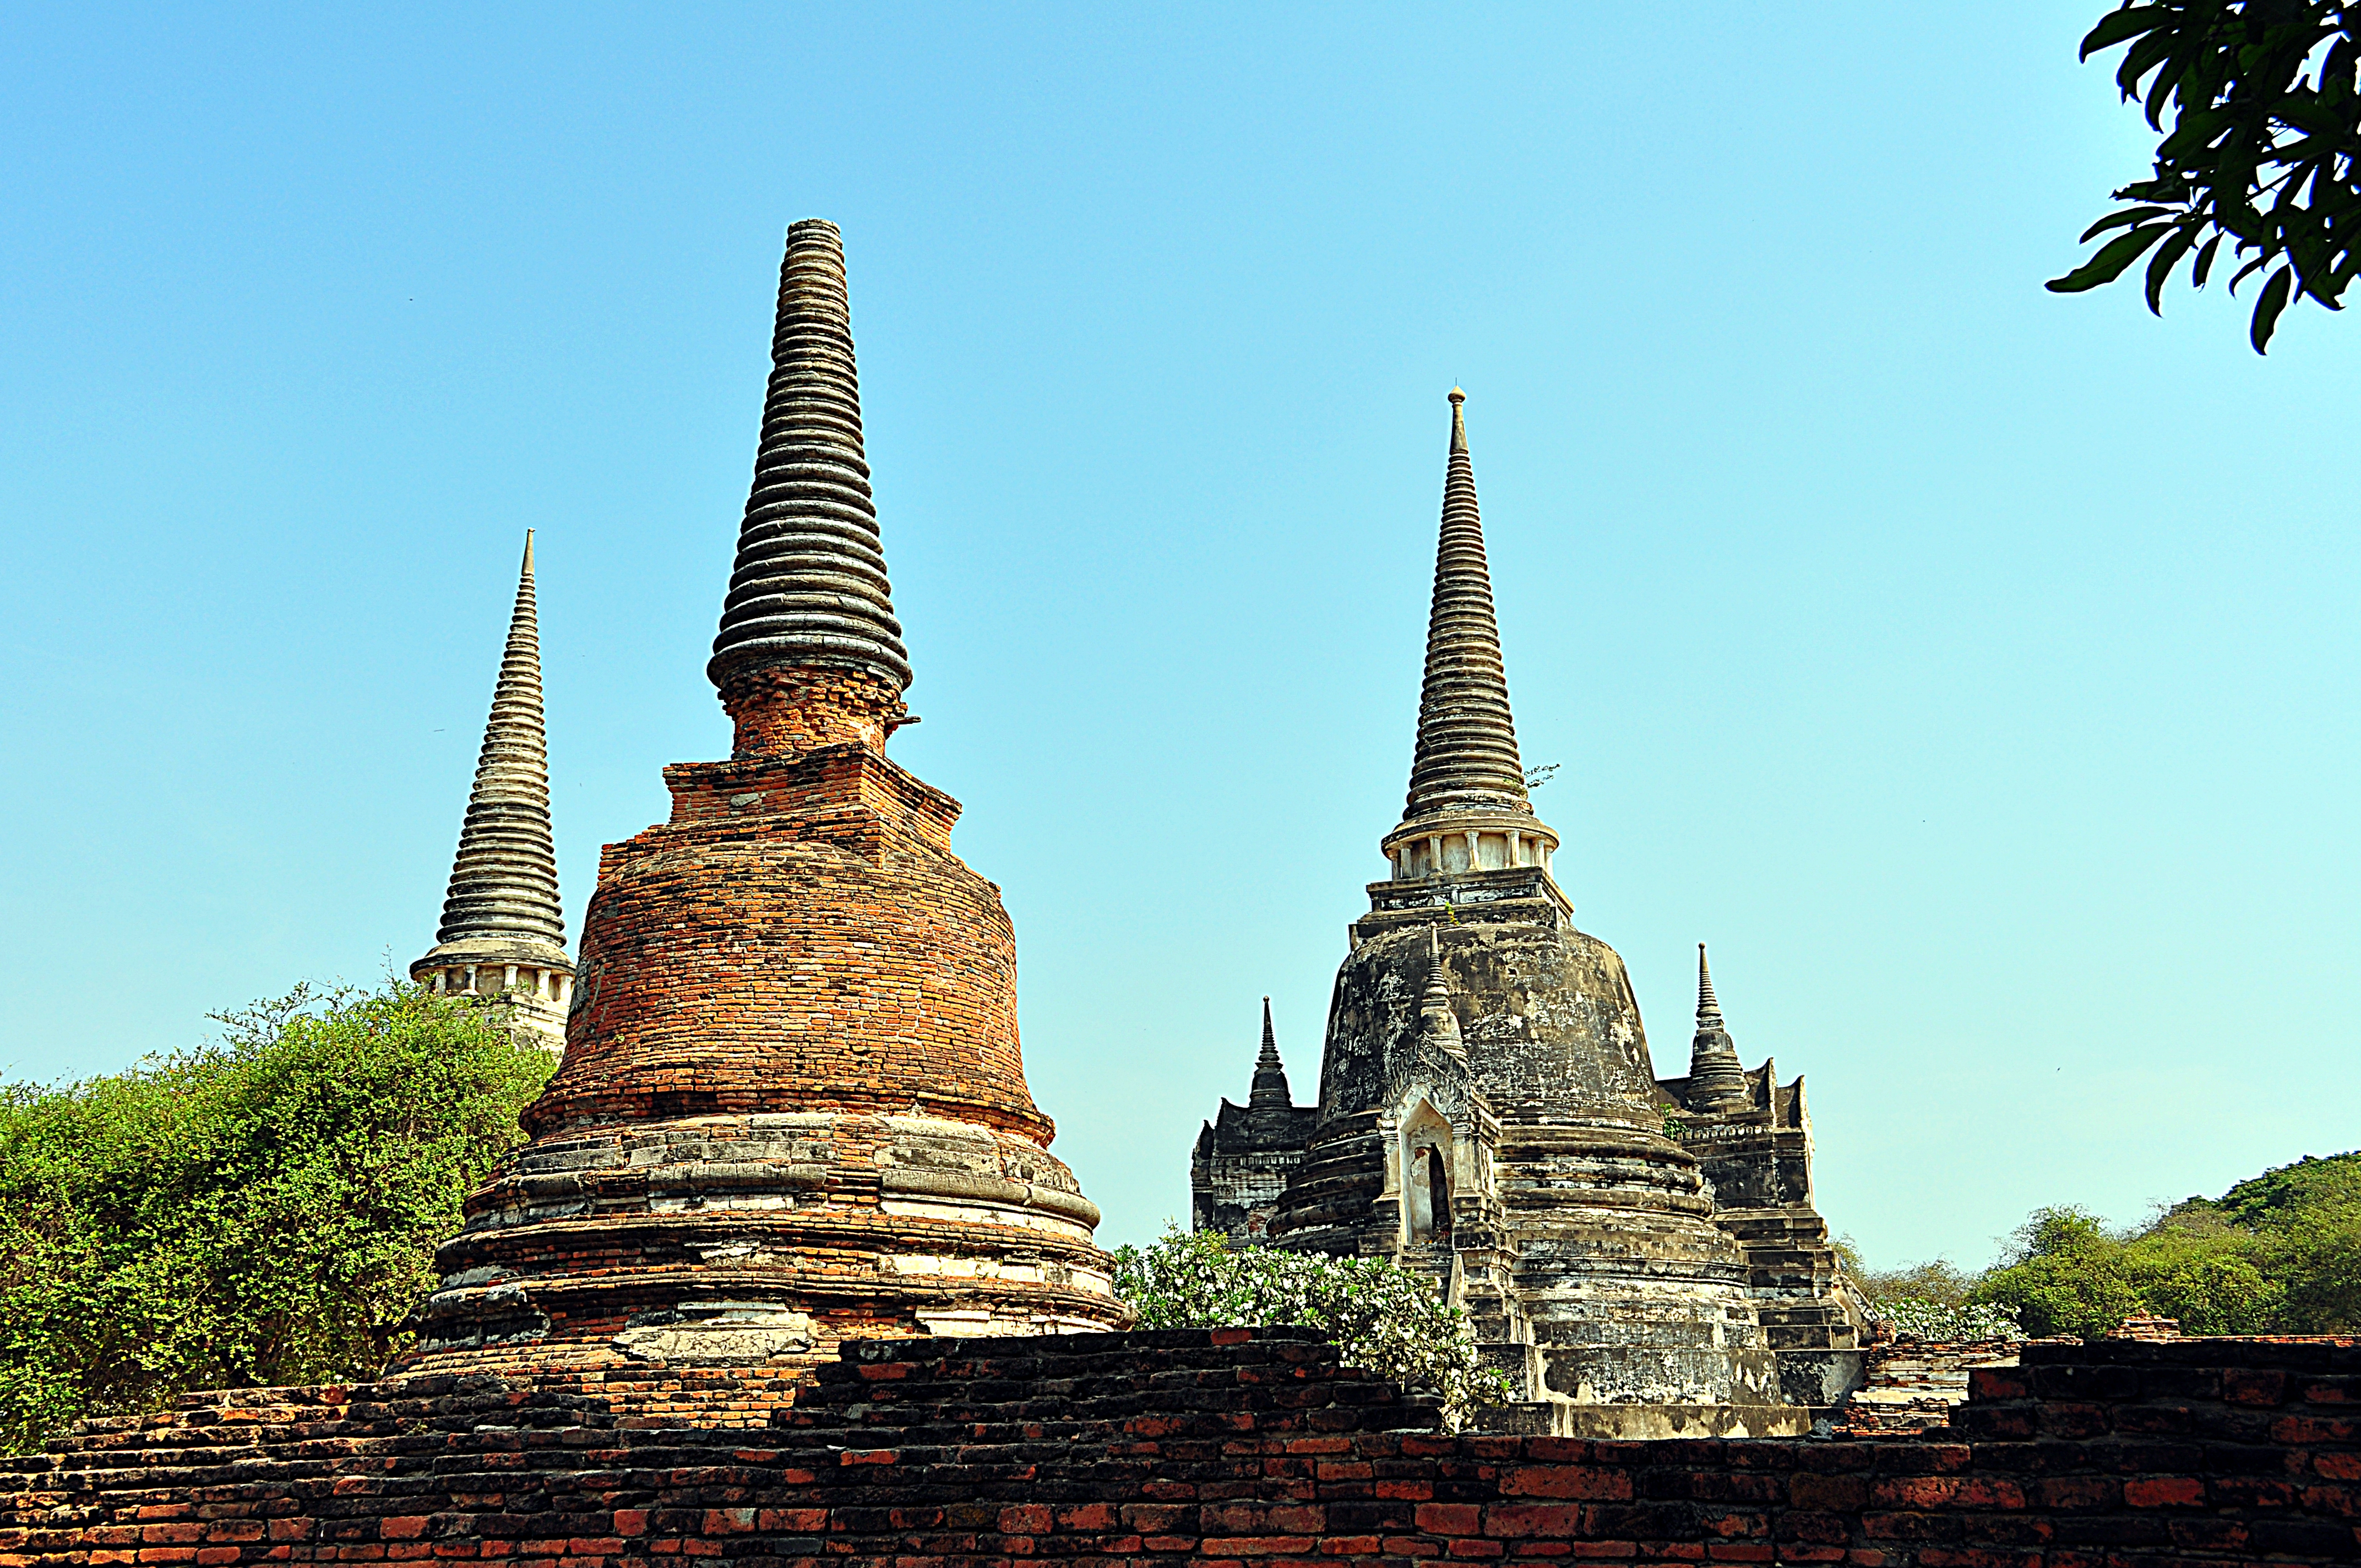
left=2049, top=0, right=2361, bottom=354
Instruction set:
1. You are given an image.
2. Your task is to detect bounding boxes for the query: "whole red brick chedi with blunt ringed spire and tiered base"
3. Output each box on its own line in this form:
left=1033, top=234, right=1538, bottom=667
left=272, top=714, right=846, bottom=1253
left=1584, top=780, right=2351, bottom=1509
left=406, top=220, right=1126, bottom=1370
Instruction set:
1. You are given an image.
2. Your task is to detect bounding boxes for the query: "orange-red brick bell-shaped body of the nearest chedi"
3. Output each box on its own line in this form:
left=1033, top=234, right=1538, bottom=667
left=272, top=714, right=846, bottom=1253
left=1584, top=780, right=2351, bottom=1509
left=547, top=746, right=1053, bottom=1145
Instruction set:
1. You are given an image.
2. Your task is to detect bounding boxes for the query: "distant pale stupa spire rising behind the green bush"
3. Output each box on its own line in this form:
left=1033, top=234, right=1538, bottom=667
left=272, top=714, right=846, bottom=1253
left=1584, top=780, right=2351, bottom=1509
left=411, top=529, right=574, bottom=1051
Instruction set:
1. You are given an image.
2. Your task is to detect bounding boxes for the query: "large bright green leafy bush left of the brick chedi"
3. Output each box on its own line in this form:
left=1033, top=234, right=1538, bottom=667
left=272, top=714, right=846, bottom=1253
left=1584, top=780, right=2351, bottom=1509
left=0, top=982, right=552, bottom=1452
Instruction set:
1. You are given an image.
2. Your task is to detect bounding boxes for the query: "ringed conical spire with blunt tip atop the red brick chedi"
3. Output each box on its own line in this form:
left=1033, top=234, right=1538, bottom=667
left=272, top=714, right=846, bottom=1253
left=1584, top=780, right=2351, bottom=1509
left=706, top=217, right=911, bottom=701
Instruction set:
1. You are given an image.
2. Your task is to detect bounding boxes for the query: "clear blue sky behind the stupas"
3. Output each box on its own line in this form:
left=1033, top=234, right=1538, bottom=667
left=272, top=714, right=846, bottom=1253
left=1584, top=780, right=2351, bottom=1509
left=0, top=0, right=2361, bottom=1264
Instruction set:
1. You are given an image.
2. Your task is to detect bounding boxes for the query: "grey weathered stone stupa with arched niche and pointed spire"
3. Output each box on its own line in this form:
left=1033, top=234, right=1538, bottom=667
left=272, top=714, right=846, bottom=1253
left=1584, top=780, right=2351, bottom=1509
left=1272, top=387, right=1809, bottom=1436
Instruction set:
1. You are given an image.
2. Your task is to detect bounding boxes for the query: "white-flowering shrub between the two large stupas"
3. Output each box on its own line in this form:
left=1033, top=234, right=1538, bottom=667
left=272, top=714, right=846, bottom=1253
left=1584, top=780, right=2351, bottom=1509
left=1114, top=1223, right=1509, bottom=1427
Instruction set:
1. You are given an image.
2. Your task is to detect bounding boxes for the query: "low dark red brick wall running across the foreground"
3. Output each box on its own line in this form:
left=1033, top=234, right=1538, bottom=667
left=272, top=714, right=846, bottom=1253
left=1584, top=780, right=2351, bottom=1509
left=0, top=1330, right=2361, bottom=1568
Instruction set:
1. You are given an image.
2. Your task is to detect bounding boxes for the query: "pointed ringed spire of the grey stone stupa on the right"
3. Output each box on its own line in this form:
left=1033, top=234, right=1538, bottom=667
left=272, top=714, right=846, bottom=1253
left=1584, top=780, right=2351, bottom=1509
left=1402, top=387, right=1532, bottom=822
